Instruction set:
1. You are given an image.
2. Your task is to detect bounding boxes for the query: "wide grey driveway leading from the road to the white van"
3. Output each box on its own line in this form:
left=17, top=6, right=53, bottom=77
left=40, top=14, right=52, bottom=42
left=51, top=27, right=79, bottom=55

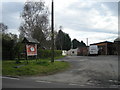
left=22, top=56, right=118, bottom=87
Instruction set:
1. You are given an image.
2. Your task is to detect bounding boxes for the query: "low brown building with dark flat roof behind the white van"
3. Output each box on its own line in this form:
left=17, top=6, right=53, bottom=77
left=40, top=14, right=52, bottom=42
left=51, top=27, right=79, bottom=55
left=90, top=41, right=114, bottom=55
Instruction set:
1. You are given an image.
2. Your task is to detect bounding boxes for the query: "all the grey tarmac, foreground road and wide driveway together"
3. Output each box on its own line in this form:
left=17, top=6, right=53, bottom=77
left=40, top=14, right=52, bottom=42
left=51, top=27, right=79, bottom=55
left=3, top=56, right=118, bottom=88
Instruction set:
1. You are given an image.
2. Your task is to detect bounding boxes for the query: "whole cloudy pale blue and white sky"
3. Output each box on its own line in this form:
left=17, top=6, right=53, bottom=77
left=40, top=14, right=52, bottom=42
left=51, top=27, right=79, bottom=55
left=0, top=0, right=118, bottom=44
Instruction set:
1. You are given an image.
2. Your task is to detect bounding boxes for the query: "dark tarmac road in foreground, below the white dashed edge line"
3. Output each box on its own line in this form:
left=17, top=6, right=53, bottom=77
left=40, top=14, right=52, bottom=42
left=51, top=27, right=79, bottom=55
left=2, top=77, right=81, bottom=90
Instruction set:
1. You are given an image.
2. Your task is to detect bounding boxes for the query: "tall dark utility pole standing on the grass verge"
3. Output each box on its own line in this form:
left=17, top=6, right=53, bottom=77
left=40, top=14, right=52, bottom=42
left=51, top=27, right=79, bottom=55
left=51, top=0, right=54, bottom=62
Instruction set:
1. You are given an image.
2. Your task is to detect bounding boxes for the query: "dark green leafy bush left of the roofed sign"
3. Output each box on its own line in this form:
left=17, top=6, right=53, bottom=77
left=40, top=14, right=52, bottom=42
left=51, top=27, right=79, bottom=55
left=2, top=33, right=17, bottom=59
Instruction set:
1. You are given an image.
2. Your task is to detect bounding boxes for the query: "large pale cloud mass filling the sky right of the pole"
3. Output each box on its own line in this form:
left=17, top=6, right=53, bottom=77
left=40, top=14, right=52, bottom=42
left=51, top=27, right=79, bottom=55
left=55, top=2, right=118, bottom=33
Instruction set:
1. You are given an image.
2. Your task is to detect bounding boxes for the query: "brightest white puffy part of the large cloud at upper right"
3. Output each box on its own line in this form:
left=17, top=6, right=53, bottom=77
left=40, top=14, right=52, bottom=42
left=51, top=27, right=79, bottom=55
left=88, top=6, right=118, bottom=33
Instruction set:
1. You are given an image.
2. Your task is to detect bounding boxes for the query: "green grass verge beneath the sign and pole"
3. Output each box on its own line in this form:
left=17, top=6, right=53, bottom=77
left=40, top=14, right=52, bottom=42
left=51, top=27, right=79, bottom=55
left=2, top=59, right=70, bottom=76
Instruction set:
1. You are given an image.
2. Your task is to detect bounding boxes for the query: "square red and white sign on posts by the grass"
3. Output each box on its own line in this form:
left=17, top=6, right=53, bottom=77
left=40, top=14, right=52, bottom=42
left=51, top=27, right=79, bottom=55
left=26, top=44, right=37, bottom=56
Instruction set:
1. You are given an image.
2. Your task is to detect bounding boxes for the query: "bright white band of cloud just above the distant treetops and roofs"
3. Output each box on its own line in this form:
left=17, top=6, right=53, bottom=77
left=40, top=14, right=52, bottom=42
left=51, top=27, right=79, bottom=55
left=63, top=28, right=118, bottom=44
